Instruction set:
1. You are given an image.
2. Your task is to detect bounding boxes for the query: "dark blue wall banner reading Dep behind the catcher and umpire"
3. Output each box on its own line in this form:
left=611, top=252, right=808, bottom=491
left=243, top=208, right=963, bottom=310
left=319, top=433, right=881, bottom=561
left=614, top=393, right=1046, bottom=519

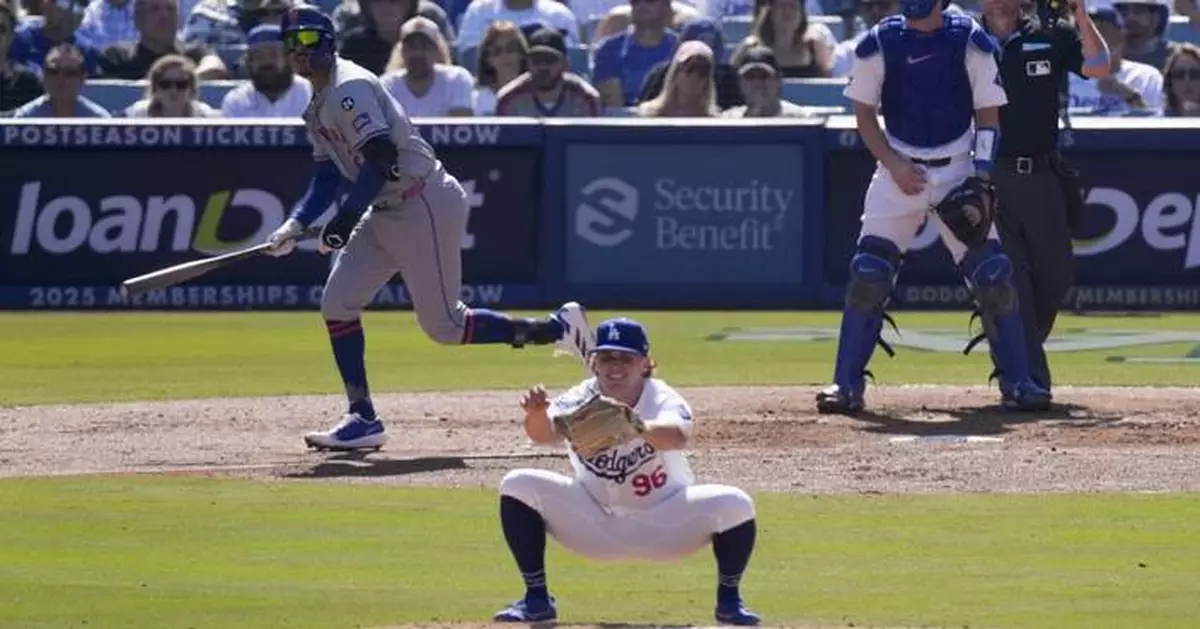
left=824, top=151, right=1200, bottom=308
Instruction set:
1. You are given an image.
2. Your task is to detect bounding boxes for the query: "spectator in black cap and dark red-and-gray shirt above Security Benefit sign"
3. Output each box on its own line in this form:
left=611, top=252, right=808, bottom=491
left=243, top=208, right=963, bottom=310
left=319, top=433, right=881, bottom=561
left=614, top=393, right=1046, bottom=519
left=496, top=29, right=602, bottom=118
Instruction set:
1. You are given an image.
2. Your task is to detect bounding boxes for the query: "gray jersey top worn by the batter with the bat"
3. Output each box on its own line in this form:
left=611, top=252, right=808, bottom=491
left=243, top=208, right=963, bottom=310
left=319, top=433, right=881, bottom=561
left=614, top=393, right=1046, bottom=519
left=304, top=58, right=438, bottom=203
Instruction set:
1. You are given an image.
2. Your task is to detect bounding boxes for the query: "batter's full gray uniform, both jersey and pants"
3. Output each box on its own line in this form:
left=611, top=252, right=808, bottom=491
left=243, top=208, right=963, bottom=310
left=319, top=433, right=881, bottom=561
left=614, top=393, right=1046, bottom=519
left=304, top=59, right=469, bottom=345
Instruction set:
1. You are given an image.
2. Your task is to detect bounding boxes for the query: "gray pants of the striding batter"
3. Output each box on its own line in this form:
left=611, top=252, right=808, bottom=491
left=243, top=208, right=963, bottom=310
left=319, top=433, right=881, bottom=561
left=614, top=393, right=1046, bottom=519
left=320, top=167, right=469, bottom=345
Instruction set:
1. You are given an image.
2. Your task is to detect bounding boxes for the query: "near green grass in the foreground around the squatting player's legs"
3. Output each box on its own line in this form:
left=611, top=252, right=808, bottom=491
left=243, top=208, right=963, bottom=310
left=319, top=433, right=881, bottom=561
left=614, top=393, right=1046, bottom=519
left=0, top=478, right=1200, bottom=629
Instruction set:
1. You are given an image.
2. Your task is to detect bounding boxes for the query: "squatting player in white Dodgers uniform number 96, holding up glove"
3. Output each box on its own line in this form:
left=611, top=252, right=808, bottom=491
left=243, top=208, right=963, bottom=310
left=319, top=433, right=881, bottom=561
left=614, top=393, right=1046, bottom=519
left=493, top=317, right=760, bottom=625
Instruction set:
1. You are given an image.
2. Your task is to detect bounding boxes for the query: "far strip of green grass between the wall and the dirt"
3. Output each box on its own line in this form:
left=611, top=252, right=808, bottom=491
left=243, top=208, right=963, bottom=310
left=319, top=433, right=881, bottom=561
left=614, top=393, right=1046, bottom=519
left=0, top=312, right=1200, bottom=406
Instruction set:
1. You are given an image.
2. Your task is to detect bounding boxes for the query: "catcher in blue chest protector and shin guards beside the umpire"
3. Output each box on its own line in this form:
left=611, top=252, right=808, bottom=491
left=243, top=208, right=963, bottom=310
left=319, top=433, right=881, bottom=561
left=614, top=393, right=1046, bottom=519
left=817, top=0, right=1049, bottom=413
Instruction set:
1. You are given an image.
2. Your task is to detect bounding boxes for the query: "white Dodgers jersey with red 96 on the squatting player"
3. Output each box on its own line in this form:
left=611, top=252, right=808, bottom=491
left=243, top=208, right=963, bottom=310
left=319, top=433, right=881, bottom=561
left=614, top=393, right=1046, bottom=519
left=547, top=378, right=696, bottom=509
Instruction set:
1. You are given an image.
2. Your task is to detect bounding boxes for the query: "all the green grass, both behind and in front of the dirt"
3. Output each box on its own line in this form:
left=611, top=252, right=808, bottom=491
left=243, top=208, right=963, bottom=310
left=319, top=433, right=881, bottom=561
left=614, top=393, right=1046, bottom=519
left=0, top=312, right=1200, bottom=629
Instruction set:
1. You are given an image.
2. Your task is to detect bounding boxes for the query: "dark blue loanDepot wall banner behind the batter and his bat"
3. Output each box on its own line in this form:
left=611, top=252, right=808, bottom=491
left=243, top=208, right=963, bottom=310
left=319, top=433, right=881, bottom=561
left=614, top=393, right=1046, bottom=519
left=0, top=148, right=541, bottom=308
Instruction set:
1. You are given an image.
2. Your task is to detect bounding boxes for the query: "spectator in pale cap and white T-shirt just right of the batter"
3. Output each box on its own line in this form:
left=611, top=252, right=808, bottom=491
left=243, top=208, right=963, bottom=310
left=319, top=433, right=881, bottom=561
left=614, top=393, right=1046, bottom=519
left=380, top=16, right=475, bottom=118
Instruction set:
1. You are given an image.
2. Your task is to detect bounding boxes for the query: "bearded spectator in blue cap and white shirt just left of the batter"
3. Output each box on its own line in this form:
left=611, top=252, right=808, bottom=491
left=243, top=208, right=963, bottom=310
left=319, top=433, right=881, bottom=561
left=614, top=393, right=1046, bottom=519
left=221, top=24, right=312, bottom=118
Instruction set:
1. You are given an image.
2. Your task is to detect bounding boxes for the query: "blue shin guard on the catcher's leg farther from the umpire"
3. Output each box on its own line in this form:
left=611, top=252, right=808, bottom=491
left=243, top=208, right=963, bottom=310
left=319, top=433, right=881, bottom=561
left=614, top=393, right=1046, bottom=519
left=834, top=236, right=900, bottom=391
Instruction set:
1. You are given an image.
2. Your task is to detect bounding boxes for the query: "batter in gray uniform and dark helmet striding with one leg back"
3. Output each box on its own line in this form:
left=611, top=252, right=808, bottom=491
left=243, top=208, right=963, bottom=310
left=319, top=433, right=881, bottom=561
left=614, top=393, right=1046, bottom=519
left=268, top=5, right=590, bottom=450
